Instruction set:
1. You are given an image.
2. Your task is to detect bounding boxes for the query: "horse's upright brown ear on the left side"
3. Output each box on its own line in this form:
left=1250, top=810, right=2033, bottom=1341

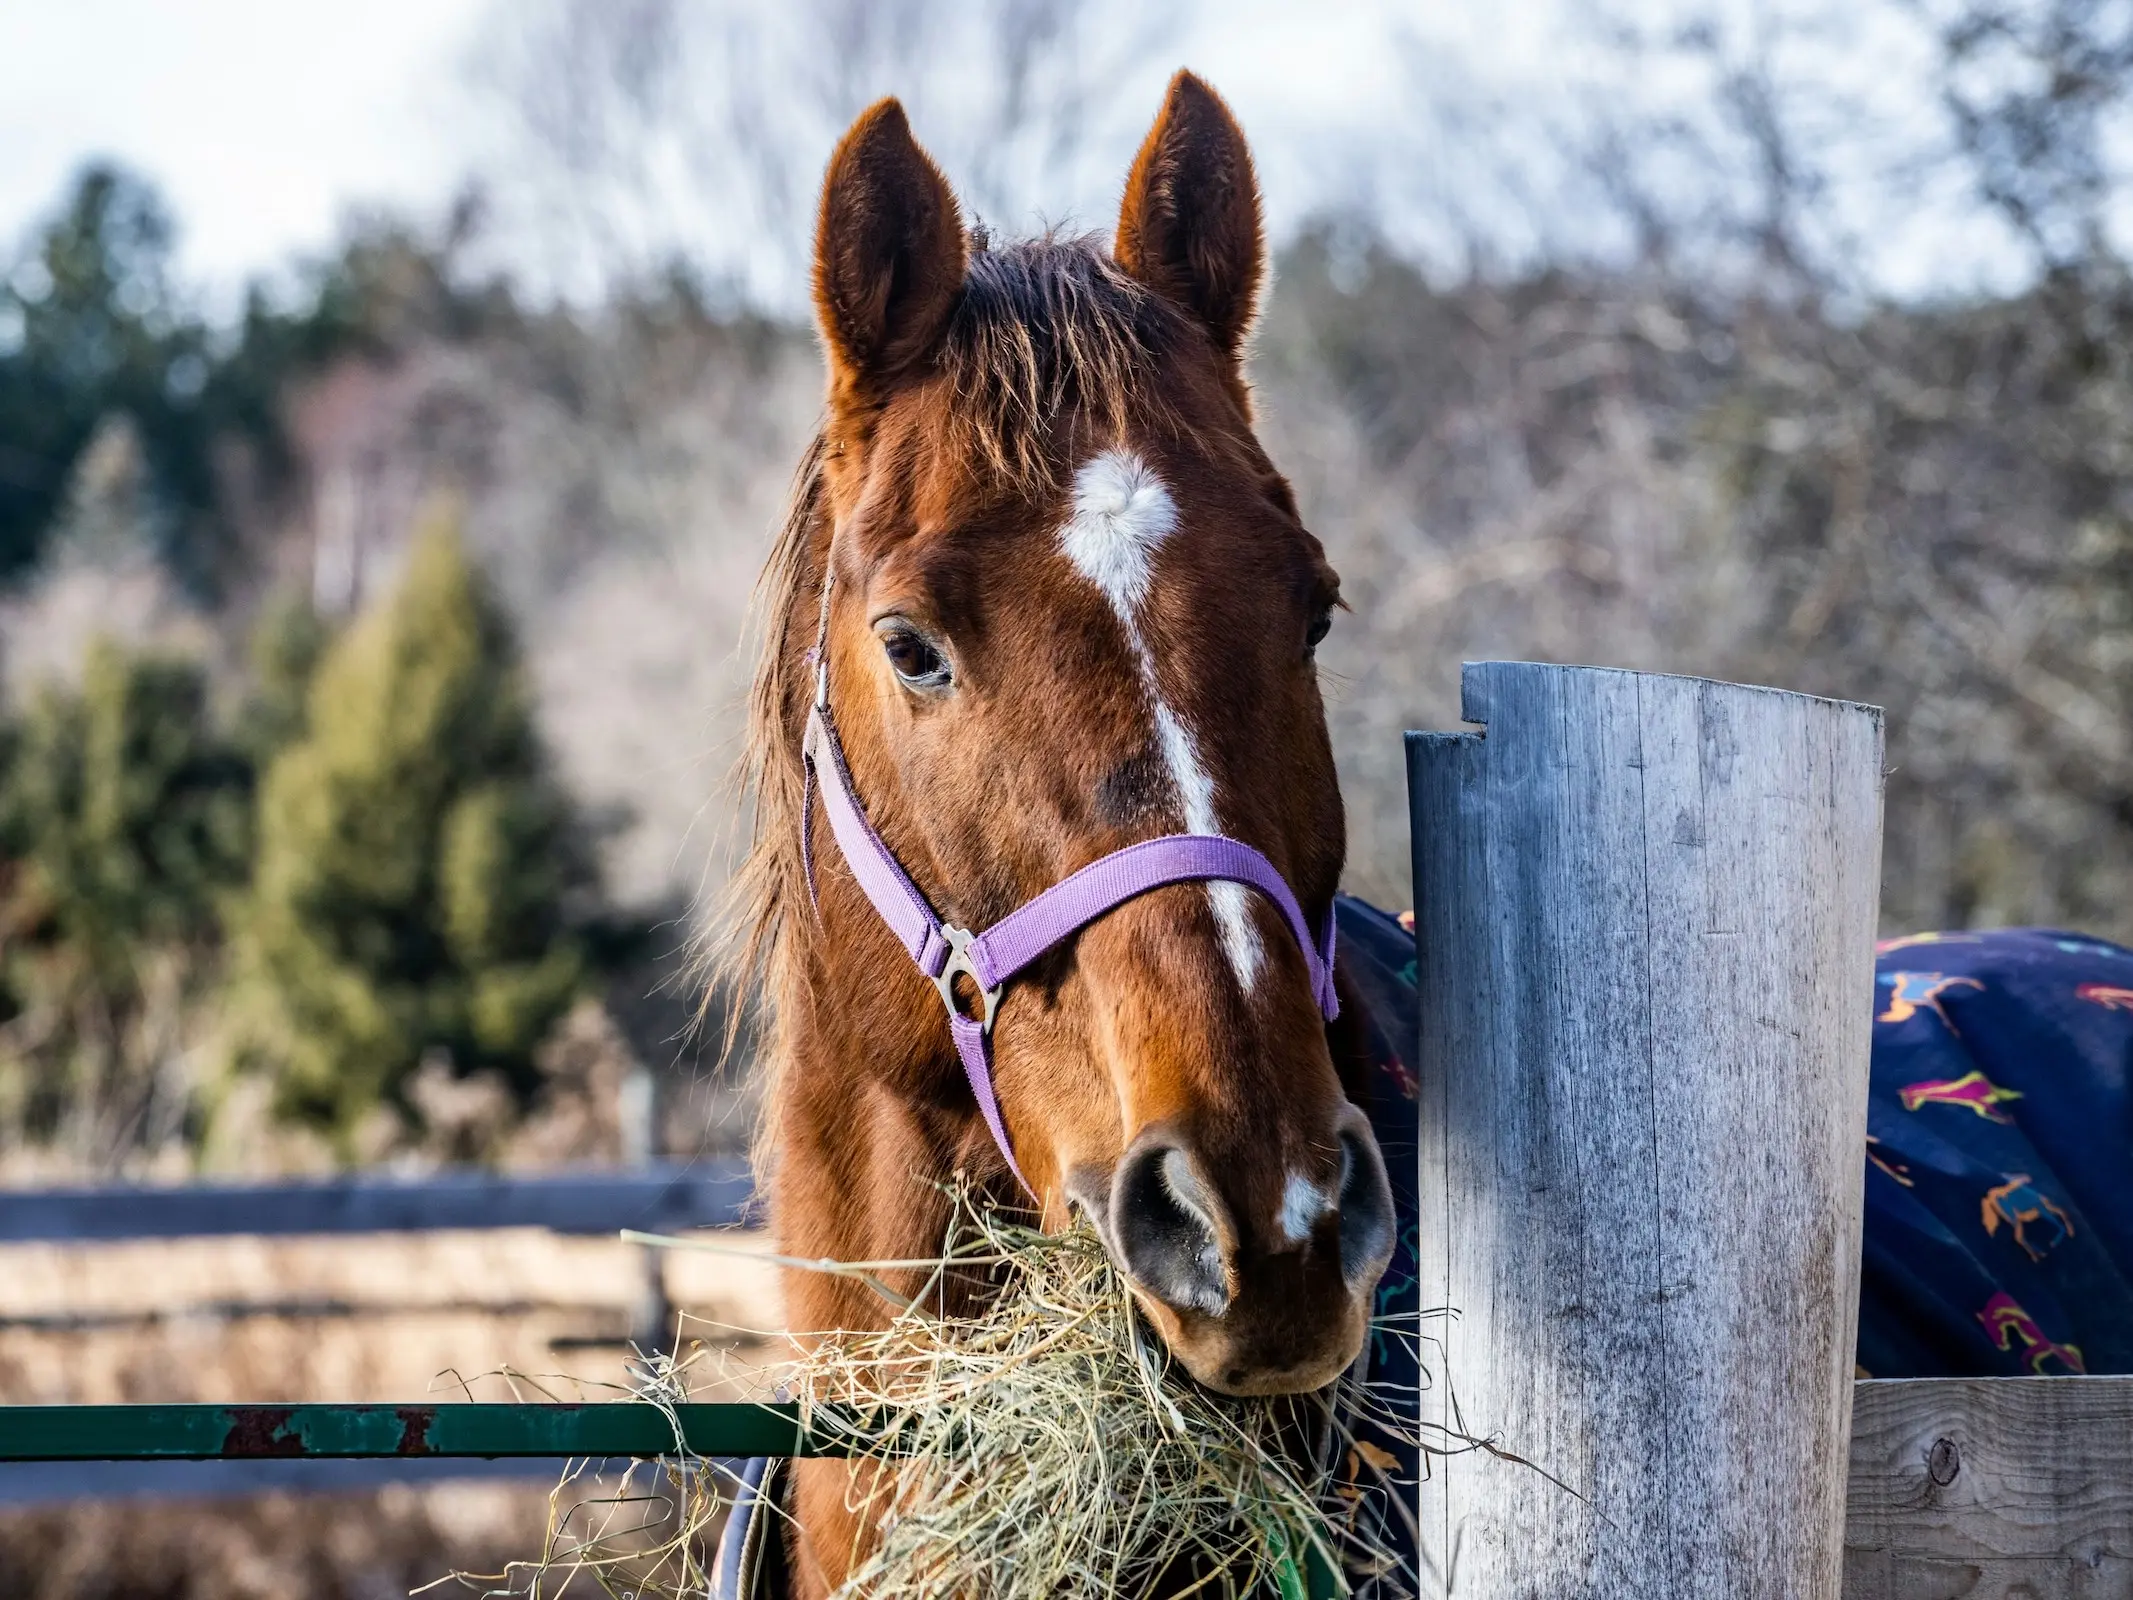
left=815, top=100, right=966, bottom=397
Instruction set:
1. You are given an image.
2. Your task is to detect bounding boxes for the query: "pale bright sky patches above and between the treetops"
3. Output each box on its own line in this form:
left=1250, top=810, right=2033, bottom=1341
left=0, top=0, right=2047, bottom=303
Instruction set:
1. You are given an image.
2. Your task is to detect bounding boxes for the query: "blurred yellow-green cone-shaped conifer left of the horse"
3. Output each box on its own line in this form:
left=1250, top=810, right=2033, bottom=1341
left=239, top=516, right=593, bottom=1139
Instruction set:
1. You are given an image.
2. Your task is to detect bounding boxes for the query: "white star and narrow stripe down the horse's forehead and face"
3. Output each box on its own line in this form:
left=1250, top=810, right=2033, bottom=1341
left=1060, top=450, right=1265, bottom=994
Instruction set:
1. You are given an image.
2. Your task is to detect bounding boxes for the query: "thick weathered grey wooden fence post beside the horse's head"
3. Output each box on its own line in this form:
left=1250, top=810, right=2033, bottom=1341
left=1408, top=661, right=1881, bottom=1600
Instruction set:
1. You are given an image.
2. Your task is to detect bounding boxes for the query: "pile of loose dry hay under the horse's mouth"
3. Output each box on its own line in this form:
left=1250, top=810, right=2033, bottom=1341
left=484, top=1203, right=1412, bottom=1600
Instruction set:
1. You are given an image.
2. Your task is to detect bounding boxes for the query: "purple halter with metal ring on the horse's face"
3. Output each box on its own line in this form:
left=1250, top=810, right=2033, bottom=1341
left=800, top=582, right=1340, bottom=1199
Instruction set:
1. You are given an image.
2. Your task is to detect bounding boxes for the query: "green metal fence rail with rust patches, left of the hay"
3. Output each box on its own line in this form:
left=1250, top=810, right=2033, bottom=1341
left=0, top=1402, right=840, bottom=1461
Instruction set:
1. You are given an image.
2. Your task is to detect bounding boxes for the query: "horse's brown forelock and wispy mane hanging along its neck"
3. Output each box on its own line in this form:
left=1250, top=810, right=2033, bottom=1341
left=702, top=233, right=1188, bottom=1173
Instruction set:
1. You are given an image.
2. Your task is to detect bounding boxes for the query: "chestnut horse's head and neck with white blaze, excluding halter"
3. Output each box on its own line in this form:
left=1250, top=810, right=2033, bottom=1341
left=753, top=73, right=1393, bottom=1393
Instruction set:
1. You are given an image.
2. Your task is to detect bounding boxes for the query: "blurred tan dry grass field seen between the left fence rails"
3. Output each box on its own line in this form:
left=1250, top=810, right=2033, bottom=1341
left=0, top=1229, right=781, bottom=1600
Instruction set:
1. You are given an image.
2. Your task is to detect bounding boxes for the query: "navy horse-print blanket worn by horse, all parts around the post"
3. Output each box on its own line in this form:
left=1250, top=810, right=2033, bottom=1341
left=715, top=913, right=2133, bottom=1600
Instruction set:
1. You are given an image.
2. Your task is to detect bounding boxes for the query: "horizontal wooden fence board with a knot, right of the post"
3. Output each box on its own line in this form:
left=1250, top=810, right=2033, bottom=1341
left=1845, top=1378, right=2133, bottom=1600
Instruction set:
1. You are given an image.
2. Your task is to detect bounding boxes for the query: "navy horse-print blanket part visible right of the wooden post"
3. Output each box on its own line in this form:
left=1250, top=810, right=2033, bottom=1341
left=1860, top=928, right=2133, bottom=1378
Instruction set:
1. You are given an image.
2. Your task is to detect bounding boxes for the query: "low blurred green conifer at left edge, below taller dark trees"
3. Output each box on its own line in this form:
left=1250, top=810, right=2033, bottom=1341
left=0, top=640, right=252, bottom=1169
